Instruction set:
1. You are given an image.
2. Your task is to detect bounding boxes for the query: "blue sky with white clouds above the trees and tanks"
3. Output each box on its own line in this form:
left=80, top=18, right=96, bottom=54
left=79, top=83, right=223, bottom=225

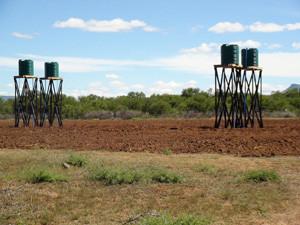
left=0, top=0, right=300, bottom=97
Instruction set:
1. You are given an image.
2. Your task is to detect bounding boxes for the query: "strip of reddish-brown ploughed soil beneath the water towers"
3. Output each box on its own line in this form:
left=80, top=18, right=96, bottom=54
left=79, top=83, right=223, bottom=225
left=0, top=119, right=300, bottom=156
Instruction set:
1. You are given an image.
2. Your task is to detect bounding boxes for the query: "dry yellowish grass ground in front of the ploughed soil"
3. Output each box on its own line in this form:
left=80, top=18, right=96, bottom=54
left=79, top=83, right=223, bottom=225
left=0, top=149, right=300, bottom=225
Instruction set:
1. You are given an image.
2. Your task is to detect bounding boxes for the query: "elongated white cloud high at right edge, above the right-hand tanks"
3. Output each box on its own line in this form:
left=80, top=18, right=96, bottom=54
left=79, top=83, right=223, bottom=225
left=208, top=22, right=300, bottom=33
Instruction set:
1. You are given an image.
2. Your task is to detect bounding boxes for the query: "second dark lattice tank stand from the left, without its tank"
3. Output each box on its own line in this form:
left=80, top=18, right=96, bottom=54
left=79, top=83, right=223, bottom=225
left=40, top=77, right=63, bottom=127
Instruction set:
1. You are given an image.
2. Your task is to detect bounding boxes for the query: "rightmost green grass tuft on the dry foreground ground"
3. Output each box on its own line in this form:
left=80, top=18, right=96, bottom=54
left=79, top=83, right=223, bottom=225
left=241, top=169, right=281, bottom=183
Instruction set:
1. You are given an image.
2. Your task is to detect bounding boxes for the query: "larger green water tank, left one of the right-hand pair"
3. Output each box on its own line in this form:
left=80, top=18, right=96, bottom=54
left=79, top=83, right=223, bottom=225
left=221, top=44, right=239, bottom=66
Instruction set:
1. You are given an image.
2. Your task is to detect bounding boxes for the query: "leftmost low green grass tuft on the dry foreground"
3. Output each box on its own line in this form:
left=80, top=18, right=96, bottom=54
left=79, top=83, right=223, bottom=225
left=26, top=170, right=69, bottom=183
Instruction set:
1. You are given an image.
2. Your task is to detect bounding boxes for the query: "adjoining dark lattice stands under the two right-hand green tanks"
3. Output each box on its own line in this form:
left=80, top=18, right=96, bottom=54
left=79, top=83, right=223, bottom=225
left=214, top=64, right=263, bottom=128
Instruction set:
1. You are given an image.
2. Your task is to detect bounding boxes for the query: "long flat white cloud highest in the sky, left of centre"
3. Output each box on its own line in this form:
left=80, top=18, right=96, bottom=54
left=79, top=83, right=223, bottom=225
left=53, top=17, right=159, bottom=33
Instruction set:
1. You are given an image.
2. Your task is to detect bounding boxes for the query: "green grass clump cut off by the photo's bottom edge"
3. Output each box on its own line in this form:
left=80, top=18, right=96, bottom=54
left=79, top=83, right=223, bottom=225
left=125, top=212, right=213, bottom=225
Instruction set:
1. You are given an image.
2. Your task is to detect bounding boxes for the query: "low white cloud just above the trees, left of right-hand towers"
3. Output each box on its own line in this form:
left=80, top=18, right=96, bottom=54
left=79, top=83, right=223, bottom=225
left=148, top=80, right=197, bottom=94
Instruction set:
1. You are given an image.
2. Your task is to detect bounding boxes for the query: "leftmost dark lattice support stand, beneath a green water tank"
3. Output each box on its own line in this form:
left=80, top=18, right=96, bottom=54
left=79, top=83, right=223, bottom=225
left=14, top=75, right=38, bottom=127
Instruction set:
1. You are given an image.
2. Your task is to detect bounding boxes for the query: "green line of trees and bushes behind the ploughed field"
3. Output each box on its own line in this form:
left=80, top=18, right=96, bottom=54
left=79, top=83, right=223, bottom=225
left=0, top=88, right=300, bottom=119
